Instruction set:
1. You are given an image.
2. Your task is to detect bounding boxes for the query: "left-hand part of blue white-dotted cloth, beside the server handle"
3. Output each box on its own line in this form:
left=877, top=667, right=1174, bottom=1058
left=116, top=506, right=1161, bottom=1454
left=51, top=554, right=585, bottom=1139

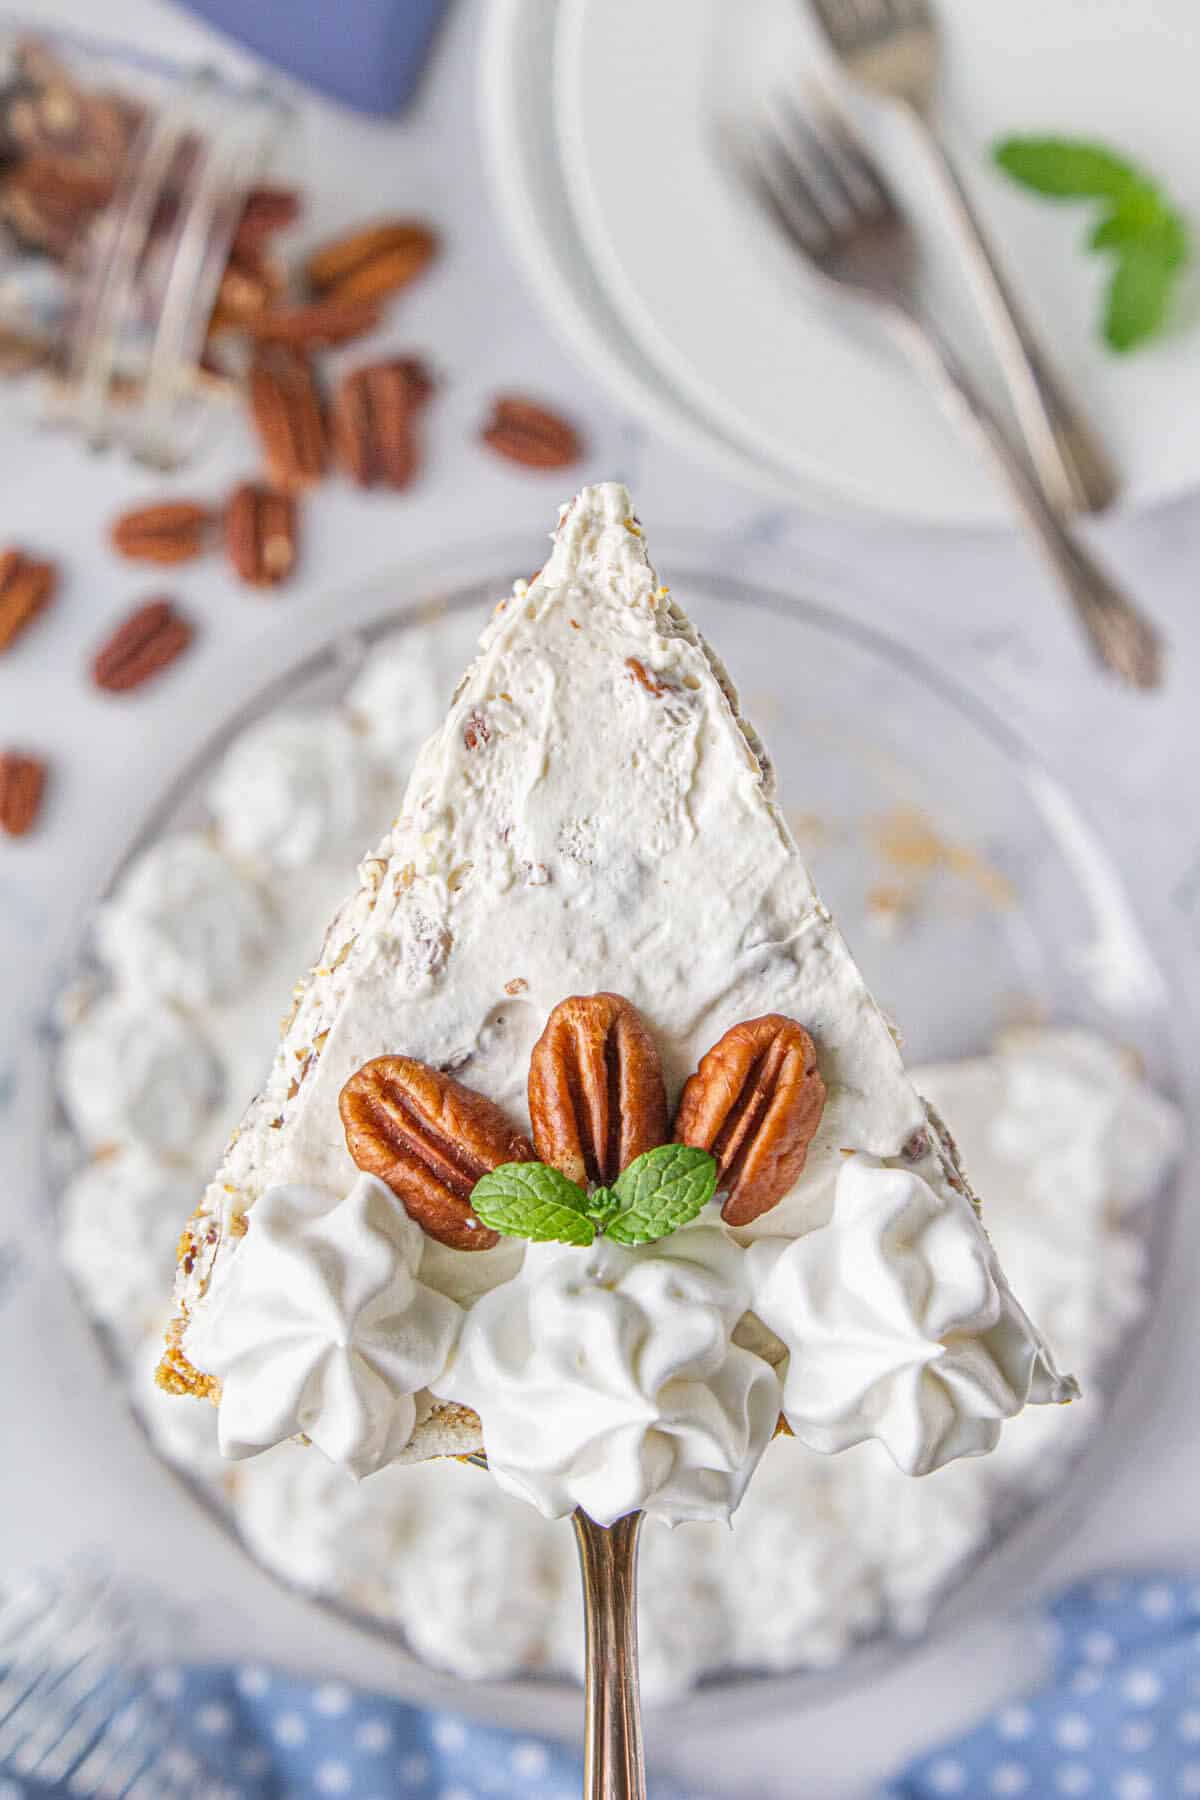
left=0, top=1663, right=696, bottom=1800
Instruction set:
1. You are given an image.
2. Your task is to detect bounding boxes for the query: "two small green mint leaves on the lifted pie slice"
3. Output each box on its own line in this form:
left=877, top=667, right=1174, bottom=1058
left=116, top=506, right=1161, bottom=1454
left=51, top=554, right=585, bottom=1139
left=471, top=1143, right=716, bottom=1247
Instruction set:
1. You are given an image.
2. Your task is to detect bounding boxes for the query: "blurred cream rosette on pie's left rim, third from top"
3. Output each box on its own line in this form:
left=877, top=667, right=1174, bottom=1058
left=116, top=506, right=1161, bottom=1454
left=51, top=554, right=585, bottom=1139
left=95, top=835, right=268, bottom=1006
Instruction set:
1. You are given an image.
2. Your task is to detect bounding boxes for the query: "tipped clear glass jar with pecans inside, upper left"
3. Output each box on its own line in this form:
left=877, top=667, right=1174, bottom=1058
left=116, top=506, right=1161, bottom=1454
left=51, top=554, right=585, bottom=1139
left=0, top=22, right=299, bottom=468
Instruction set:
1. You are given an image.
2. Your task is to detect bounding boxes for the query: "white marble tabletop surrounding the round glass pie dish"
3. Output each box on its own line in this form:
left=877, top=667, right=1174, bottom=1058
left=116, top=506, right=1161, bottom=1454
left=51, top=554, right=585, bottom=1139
left=0, top=0, right=1200, bottom=1800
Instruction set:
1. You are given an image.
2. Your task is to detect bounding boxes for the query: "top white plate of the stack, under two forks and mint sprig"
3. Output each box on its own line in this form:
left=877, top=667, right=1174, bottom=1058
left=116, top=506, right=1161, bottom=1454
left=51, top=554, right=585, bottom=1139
left=543, top=0, right=1200, bottom=522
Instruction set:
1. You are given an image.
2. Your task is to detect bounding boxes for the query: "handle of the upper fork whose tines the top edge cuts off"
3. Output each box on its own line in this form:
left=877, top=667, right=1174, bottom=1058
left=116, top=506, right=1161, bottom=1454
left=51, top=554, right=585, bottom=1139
left=907, top=103, right=1117, bottom=513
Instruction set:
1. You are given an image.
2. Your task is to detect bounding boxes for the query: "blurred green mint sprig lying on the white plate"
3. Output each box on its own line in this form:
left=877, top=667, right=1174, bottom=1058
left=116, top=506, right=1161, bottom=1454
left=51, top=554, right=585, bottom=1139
left=991, top=137, right=1191, bottom=351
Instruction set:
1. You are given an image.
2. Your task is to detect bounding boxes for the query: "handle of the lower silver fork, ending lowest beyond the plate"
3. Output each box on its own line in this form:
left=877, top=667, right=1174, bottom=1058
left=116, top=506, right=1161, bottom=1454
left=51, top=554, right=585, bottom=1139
left=901, top=313, right=1162, bottom=688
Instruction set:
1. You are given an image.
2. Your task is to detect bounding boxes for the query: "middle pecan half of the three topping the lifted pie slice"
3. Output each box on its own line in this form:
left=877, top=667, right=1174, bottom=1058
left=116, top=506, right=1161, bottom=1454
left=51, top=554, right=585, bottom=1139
left=529, top=994, right=667, bottom=1183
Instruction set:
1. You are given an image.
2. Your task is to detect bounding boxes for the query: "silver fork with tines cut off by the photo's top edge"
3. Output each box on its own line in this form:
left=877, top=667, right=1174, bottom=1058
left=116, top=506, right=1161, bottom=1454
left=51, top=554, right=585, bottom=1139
left=810, top=0, right=1117, bottom=511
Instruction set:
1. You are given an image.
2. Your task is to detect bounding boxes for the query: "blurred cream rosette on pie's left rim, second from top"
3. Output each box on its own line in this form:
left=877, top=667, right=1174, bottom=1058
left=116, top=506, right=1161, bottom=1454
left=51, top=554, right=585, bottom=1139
left=209, top=707, right=374, bottom=869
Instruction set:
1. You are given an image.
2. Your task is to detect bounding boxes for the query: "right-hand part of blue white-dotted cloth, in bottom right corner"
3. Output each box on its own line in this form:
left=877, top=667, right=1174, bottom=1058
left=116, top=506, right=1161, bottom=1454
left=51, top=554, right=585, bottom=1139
left=880, top=1575, right=1200, bottom=1800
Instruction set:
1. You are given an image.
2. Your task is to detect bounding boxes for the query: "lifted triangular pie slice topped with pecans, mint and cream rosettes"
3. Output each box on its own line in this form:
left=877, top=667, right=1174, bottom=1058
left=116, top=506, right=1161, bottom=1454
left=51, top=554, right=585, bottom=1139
left=158, top=484, right=1074, bottom=1519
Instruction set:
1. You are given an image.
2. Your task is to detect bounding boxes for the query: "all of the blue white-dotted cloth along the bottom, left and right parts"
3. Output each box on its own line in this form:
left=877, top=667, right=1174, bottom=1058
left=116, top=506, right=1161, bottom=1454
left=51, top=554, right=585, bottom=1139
left=0, top=1573, right=1200, bottom=1800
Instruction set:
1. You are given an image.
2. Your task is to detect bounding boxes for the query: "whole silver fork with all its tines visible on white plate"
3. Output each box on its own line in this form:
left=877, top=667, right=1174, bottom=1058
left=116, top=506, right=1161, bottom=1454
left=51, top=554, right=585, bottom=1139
left=736, top=104, right=1162, bottom=688
